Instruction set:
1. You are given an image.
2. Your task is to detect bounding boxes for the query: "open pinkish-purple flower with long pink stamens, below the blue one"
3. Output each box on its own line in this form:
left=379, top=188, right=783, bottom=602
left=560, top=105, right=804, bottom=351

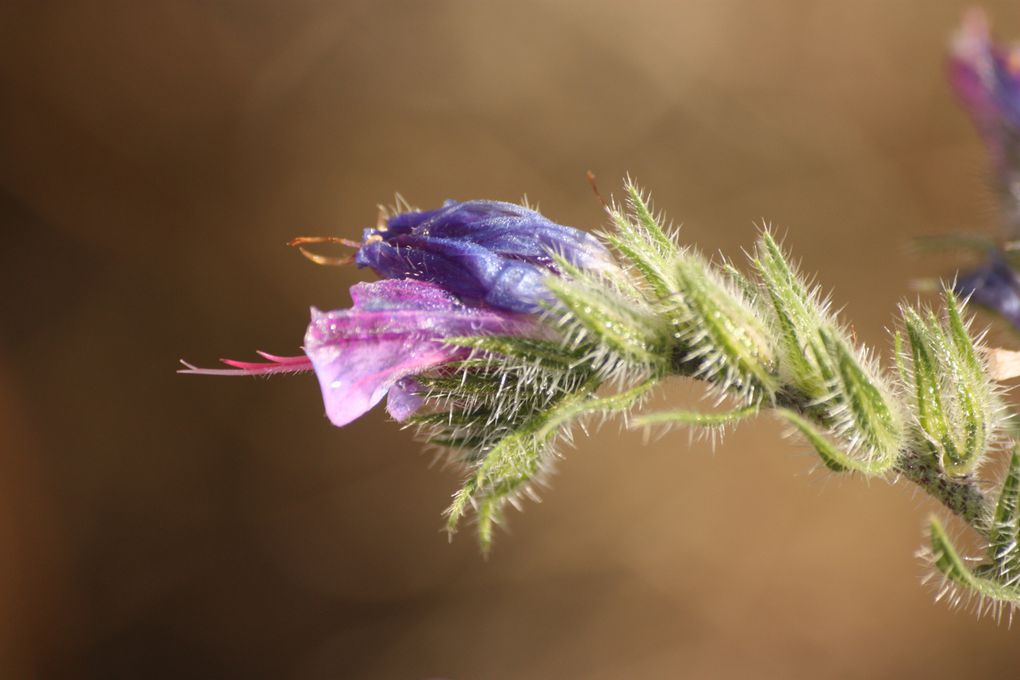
left=181, top=280, right=541, bottom=426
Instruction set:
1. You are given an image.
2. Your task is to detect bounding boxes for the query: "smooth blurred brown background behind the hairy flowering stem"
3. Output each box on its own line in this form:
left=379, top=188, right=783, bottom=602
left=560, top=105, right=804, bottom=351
left=0, top=0, right=1020, bottom=680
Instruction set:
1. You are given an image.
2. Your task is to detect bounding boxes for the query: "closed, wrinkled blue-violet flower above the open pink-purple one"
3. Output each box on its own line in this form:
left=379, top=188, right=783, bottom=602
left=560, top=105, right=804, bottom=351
left=355, top=201, right=613, bottom=312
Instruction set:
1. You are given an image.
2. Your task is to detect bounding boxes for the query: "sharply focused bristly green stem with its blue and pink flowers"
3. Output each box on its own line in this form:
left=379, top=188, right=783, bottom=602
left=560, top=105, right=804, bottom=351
left=183, top=180, right=1020, bottom=615
